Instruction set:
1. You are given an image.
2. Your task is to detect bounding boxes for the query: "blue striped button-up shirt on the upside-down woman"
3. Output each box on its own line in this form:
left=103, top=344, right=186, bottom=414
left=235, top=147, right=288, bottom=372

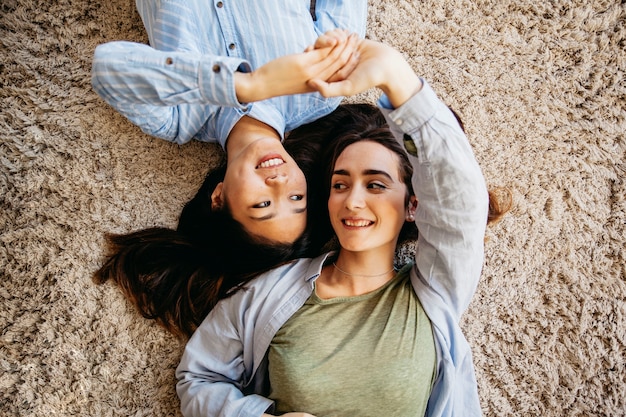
left=92, top=0, right=367, bottom=146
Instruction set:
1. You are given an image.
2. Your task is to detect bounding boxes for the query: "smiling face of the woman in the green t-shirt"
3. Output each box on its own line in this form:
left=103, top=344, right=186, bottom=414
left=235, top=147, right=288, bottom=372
left=328, top=141, right=407, bottom=252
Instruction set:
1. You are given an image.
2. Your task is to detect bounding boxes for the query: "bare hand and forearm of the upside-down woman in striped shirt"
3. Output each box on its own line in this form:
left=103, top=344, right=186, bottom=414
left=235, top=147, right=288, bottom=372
left=235, top=32, right=358, bottom=103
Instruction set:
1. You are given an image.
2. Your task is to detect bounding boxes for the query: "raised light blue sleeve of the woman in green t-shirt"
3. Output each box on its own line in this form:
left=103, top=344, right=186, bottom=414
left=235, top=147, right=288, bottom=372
left=380, top=82, right=489, bottom=321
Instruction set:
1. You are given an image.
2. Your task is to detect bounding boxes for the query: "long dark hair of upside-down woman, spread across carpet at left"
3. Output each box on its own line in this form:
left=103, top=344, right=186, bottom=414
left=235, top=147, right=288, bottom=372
left=94, top=167, right=327, bottom=337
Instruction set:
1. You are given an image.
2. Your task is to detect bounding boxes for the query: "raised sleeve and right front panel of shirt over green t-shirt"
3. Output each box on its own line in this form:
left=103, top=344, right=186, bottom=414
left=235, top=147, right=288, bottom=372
left=379, top=79, right=488, bottom=417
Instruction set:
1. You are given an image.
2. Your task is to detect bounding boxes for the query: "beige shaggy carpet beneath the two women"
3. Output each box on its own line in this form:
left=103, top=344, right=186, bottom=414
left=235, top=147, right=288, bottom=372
left=0, top=0, right=626, bottom=417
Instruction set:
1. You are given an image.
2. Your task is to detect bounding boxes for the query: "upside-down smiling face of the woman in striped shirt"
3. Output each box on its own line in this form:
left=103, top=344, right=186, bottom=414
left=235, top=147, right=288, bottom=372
left=211, top=137, right=307, bottom=243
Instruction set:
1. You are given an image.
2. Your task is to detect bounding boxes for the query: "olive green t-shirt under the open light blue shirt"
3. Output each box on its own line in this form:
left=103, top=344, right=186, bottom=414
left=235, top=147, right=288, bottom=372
left=269, top=267, right=436, bottom=417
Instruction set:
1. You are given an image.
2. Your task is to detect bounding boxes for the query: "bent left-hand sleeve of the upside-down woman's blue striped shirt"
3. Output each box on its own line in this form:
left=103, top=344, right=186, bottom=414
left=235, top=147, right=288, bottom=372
left=91, top=41, right=249, bottom=144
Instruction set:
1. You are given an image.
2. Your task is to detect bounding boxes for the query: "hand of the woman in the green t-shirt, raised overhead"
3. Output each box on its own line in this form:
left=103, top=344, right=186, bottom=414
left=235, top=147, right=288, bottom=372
left=309, top=39, right=422, bottom=107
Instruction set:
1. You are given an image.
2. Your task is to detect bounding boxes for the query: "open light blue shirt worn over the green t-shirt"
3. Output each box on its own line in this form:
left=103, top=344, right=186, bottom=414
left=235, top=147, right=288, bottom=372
left=176, top=83, right=488, bottom=417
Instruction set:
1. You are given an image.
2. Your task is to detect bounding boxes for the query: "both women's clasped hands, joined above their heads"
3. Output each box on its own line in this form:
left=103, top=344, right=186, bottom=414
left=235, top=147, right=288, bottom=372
left=235, top=29, right=422, bottom=107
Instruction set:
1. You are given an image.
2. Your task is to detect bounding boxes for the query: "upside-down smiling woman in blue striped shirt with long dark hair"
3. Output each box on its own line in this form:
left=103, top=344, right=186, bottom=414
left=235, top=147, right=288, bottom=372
left=92, top=0, right=367, bottom=334
